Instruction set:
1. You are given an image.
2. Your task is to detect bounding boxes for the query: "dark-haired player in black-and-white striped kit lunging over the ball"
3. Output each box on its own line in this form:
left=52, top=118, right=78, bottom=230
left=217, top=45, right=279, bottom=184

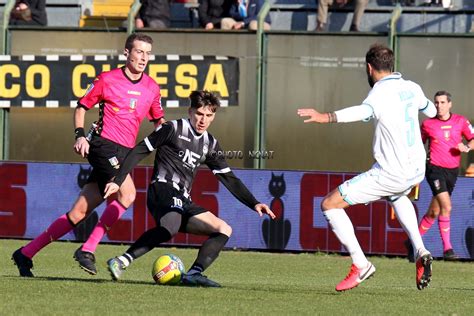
left=104, top=91, right=275, bottom=287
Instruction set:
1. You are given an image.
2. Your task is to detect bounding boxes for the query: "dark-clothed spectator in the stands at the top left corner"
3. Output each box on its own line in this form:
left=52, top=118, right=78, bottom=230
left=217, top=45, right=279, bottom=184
left=10, top=0, right=48, bottom=26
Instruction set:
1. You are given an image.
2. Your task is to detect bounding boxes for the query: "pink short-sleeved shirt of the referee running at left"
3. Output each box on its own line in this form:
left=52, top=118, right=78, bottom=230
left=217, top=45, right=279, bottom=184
left=78, top=67, right=164, bottom=148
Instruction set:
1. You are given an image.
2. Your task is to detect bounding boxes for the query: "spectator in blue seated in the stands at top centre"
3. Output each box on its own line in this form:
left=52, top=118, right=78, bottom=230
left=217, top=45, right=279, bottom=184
left=221, top=0, right=272, bottom=31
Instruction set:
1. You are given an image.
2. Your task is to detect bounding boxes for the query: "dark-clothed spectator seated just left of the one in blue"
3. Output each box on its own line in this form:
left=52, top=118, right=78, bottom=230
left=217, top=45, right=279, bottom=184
left=198, top=0, right=234, bottom=30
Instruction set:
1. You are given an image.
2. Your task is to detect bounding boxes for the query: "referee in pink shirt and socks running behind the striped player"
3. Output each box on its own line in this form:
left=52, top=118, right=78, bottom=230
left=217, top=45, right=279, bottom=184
left=12, top=34, right=164, bottom=277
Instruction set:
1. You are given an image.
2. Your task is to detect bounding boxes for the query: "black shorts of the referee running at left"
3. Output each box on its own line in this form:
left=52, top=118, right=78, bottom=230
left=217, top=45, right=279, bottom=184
left=87, top=136, right=131, bottom=193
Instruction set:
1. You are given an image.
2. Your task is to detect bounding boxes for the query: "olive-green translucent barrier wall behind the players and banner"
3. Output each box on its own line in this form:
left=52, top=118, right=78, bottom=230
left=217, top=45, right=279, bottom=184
left=4, top=29, right=474, bottom=171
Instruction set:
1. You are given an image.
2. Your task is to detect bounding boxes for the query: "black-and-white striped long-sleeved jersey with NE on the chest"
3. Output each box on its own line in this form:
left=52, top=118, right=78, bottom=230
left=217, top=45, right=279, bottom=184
left=113, top=119, right=259, bottom=209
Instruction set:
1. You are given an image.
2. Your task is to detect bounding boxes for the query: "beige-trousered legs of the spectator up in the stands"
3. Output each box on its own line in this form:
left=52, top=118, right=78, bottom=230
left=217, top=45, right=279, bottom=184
left=316, top=0, right=369, bottom=32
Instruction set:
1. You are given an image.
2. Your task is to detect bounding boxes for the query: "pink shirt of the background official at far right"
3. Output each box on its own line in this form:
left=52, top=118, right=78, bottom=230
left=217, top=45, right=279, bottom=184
left=421, top=113, right=474, bottom=168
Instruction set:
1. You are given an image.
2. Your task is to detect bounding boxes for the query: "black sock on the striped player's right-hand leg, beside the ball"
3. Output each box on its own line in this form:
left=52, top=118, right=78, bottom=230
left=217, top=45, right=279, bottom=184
left=188, top=233, right=229, bottom=274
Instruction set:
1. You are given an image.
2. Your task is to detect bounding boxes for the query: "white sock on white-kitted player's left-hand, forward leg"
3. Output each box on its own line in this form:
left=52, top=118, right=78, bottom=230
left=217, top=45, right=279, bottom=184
left=323, top=208, right=368, bottom=268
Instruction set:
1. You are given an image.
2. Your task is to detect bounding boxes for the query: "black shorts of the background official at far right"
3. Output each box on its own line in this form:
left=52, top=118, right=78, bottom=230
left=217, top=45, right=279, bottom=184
left=426, top=163, right=459, bottom=196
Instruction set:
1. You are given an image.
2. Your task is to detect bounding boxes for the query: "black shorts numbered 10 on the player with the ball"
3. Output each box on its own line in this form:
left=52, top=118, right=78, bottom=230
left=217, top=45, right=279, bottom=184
left=147, top=182, right=208, bottom=232
